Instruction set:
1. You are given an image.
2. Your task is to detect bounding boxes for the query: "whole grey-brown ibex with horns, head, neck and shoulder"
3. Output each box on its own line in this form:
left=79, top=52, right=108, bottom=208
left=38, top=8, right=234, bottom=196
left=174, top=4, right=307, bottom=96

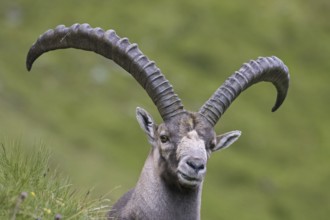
left=26, top=24, right=290, bottom=220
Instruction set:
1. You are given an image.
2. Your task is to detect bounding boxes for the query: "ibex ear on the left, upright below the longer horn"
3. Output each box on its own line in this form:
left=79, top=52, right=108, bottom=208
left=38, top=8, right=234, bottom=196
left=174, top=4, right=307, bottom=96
left=136, top=107, right=156, bottom=143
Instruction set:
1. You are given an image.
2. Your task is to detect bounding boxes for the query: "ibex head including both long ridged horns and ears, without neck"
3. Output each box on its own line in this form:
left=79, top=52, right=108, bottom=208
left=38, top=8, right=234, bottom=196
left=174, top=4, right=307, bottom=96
left=27, top=24, right=289, bottom=189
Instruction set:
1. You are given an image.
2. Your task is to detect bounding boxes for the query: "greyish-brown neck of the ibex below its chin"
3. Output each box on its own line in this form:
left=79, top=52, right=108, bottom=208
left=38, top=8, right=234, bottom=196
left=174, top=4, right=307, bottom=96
left=131, top=154, right=201, bottom=220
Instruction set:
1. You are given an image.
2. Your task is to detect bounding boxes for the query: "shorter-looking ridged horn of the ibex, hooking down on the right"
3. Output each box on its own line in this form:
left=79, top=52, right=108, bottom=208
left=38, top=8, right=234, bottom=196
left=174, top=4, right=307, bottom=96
left=199, top=56, right=290, bottom=126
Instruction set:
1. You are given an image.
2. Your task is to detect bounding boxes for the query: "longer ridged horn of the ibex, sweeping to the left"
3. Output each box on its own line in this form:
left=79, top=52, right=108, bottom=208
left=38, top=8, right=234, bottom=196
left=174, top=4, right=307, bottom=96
left=26, top=24, right=183, bottom=121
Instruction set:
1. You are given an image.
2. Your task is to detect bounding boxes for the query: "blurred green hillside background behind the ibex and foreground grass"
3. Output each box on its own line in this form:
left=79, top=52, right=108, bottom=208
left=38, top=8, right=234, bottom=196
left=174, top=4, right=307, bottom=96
left=0, top=0, right=330, bottom=220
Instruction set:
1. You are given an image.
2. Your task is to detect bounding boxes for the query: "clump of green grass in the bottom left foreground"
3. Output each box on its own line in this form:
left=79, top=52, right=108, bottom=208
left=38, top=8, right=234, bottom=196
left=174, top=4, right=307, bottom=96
left=0, top=141, right=109, bottom=220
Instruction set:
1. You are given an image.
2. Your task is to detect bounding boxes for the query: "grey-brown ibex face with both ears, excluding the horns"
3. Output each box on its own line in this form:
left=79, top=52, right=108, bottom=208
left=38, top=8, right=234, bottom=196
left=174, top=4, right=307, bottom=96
left=137, top=108, right=240, bottom=188
